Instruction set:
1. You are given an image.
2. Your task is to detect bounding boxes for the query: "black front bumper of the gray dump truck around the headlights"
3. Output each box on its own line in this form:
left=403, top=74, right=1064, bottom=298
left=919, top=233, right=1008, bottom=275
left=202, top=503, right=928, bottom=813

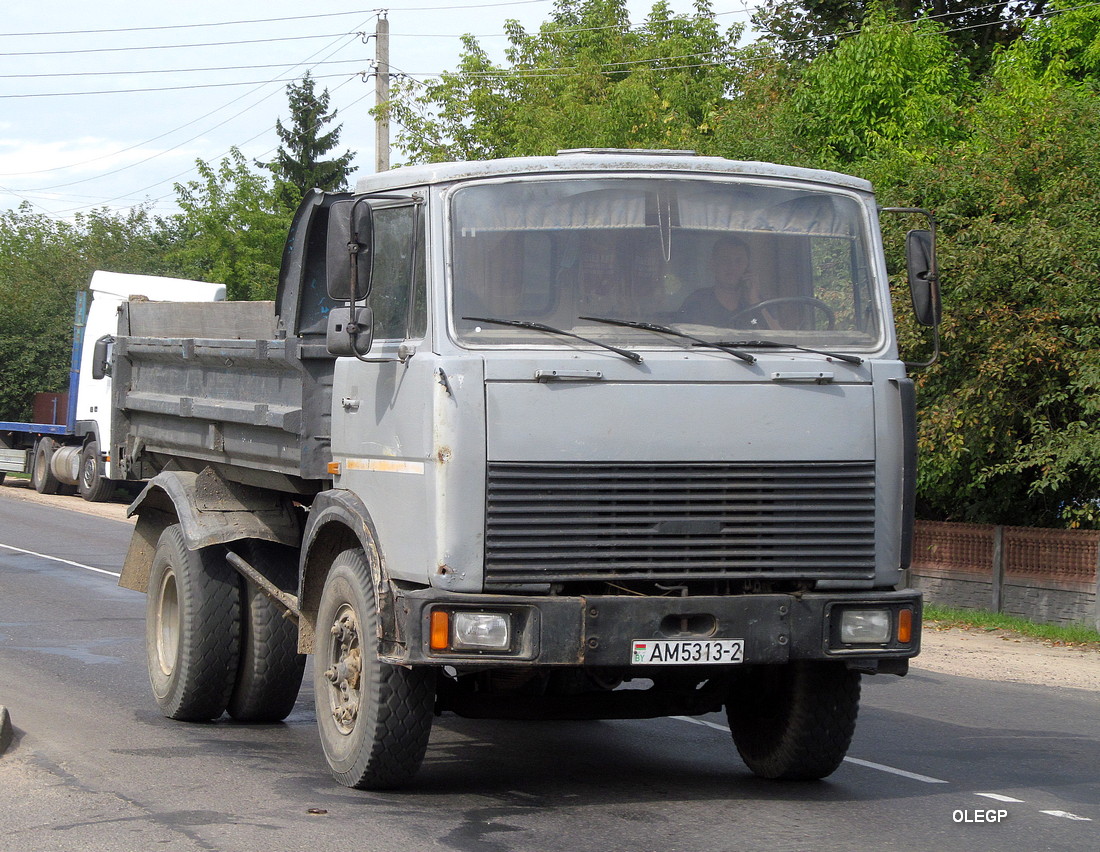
left=383, top=588, right=921, bottom=673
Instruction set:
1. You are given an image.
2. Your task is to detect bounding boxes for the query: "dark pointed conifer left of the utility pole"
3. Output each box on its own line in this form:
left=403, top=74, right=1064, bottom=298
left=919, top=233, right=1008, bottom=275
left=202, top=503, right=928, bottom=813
left=257, top=71, right=355, bottom=210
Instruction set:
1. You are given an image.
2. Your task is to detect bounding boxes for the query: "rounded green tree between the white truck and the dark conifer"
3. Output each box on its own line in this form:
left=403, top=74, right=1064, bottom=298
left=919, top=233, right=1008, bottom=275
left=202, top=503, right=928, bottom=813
left=167, top=148, right=293, bottom=299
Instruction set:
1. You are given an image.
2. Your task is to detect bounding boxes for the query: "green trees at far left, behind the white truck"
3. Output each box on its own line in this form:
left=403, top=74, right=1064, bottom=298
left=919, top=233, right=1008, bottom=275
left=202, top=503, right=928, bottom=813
left=0, top=204, right=171, bottom=420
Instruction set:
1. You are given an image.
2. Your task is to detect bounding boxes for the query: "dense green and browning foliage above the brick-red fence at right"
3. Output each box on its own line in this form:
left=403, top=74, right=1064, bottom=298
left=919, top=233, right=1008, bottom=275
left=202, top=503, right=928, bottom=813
left=884, top=81, right=1100, bottom=527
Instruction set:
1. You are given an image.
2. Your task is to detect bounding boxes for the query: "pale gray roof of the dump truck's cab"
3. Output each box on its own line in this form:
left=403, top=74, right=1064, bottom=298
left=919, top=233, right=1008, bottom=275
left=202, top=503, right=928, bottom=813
left=355, top=148, right=871, bottom=192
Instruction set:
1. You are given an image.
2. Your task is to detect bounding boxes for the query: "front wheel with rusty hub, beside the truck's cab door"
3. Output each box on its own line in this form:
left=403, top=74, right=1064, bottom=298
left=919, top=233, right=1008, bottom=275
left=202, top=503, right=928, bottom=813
left=314, top=550, right=436, bottom=789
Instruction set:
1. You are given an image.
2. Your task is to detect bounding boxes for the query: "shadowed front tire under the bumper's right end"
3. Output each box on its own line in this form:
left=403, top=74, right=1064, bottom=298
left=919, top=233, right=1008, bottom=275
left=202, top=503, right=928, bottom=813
left=726, top=662, right=859, bottom=781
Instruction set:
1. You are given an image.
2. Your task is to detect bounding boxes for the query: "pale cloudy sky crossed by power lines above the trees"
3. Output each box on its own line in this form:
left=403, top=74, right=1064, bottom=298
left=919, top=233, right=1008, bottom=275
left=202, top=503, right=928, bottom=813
left=0, top=0, right=751, bottom=219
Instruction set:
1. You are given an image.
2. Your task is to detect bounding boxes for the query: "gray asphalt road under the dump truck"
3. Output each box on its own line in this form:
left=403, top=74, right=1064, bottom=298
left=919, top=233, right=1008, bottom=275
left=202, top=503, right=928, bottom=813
left=0, top=489, right=1100, bottom=852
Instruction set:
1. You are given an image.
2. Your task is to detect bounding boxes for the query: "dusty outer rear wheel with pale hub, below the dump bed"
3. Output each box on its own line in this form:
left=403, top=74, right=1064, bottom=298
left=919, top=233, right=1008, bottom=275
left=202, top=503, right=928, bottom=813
left=145, top=523, right=241, bottom=722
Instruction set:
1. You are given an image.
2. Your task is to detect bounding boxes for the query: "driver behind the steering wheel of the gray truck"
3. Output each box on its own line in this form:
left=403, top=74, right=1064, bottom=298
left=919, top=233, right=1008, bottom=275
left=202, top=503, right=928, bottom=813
left=679, top=235, right=776, bottom=329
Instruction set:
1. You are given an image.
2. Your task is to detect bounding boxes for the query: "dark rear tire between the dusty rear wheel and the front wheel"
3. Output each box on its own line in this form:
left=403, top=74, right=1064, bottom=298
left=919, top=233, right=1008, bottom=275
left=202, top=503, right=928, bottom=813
left=226, top=540, right=306, bottom=722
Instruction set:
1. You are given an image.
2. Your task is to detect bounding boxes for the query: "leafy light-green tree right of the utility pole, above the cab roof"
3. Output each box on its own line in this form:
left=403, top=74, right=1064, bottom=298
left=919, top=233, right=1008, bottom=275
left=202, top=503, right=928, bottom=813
left=389, top=0, right=740, bottom=162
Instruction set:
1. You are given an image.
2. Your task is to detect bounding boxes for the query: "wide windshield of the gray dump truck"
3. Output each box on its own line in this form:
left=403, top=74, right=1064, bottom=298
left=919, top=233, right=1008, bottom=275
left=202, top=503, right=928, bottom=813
left=451, top=177, right=881, bottom=348
